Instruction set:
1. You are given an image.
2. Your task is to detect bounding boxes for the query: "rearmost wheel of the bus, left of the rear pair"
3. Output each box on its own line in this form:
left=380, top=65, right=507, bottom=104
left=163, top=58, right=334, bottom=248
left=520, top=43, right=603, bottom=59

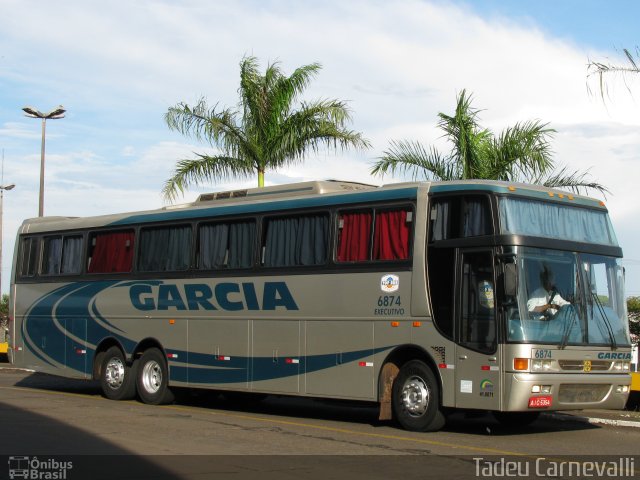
left=100, top=346, right=136, bottom=400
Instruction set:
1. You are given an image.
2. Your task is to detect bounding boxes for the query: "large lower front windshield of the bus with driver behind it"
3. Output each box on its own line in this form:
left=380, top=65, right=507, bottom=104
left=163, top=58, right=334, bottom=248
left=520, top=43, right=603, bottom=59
left=507, top=248, right=630, bottom=348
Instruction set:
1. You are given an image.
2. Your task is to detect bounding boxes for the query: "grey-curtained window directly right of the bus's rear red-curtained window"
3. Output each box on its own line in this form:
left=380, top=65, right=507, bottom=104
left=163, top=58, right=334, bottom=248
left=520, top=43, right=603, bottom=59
left=138, top=225, right=191, bottom=272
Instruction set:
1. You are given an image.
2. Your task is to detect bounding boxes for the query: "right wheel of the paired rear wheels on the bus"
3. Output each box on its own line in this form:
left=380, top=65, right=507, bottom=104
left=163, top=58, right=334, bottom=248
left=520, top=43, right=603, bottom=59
left=136, top=348, right=174, bottom=405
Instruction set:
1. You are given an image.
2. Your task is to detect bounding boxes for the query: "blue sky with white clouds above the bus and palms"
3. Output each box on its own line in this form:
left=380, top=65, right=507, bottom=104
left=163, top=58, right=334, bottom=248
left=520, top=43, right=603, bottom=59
left=0, top=0, right=640, bottom=295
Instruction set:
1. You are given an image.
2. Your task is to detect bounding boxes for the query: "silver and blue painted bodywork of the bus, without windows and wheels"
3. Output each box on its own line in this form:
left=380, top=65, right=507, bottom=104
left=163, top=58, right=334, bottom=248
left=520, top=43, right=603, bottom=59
left=11, top=181, right=629, bottom=411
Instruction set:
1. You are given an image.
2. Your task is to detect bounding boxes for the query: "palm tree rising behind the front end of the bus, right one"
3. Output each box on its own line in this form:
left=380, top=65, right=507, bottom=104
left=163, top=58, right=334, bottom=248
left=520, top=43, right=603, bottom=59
left=371, top=90, right=607, bottom=193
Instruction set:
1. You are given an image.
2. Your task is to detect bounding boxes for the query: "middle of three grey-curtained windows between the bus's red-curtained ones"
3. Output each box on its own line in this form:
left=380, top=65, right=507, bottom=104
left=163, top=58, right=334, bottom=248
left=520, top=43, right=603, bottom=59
left=198, top=220, right=256, bottom=270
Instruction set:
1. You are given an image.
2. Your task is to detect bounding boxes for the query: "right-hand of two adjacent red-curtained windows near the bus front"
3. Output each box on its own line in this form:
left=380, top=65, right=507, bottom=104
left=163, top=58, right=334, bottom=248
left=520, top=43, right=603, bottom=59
left=373, top=210, right=409, bottom=260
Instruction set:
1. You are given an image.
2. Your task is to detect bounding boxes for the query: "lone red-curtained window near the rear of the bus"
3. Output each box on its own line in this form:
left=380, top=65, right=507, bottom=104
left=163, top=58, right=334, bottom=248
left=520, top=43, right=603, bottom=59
left=87, top=232, right=133, bottom=273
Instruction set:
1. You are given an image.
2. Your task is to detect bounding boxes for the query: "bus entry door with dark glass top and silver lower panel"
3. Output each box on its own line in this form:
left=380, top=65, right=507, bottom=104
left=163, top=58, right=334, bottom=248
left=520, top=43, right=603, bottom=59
left=455, top=249, right=501, bottom=410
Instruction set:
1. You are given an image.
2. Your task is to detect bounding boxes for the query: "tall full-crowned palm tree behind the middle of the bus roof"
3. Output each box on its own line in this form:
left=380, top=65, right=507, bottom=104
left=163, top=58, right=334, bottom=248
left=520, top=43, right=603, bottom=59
left=163, top=57, right=369, bottom=200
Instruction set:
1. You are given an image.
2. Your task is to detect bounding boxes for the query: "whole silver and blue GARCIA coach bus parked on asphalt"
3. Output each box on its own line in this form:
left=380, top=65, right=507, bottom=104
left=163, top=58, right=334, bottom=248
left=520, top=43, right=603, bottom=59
left=9, top=181, right=631, bottom=431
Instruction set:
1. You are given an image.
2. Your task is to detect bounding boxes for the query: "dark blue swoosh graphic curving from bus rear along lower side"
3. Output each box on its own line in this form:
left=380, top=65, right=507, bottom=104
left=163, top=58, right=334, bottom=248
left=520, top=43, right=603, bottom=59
left=22, top=280, right=393, bottom=384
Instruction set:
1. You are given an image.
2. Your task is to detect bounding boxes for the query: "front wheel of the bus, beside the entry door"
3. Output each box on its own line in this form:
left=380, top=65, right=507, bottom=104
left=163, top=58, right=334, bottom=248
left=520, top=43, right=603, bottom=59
left=391, top=360, right=445, bottom=432
